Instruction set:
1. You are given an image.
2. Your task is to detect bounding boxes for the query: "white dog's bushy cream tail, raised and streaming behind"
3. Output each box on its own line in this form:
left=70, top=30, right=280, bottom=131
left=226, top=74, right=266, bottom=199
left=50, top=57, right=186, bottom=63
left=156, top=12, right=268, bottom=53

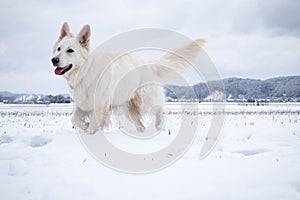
left=155, top=39, right=205, bottom=85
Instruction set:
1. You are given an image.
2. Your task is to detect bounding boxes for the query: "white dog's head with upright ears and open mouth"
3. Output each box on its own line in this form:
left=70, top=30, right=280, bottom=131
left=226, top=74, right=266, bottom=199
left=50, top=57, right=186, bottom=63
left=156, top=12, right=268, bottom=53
left=51, top=22, right=91, bottom=76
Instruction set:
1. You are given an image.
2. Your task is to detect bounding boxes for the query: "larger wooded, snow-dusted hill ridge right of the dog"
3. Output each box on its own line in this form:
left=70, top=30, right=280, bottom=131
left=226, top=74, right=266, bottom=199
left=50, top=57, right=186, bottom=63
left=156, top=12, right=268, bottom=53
left=166, top=76, right=300, bottom=102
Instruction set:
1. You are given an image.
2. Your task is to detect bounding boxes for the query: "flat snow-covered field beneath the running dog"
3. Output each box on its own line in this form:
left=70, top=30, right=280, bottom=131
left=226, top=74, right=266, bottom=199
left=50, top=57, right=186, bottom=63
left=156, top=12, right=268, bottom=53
left=0, top=104, right=300, bottom=200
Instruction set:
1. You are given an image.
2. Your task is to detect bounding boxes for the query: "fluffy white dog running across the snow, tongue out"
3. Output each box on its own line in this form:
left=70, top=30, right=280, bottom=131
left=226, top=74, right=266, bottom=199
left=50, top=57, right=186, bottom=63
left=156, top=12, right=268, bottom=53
left=51, top=23, right=204, bottom=133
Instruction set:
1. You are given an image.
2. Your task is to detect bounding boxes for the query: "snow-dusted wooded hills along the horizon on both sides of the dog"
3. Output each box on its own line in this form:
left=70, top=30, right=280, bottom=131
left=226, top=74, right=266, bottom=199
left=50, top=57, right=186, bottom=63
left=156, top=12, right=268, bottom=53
left=0, top=76, right=300, bottom=104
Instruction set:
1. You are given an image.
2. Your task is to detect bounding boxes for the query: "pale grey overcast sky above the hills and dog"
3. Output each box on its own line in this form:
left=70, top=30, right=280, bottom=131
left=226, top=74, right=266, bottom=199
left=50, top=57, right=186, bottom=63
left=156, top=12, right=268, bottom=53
left=0, top=0, right=300, bottom=94
